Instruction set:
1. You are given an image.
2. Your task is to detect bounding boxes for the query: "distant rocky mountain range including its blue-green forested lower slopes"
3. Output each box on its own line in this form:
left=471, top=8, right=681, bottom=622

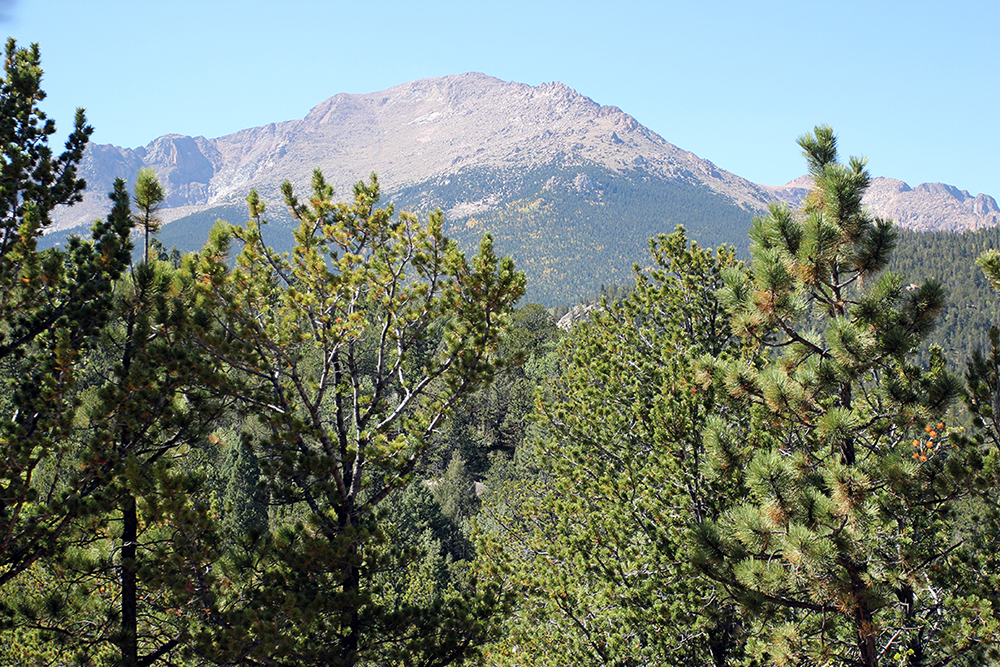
left=57, top=73, right=1000, bottom=303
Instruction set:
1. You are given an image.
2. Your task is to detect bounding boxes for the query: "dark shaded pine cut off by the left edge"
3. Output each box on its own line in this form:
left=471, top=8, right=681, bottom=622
left=0, top=39, right=131, bottom=586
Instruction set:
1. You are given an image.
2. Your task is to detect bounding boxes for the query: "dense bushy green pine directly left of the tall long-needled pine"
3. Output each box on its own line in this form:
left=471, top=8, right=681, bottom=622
left=479, top=229, right=738, bottom=665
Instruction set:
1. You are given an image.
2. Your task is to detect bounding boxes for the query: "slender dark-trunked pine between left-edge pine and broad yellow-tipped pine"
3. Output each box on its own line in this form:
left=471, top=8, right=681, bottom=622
left=9, top=172, right=229, bottom=667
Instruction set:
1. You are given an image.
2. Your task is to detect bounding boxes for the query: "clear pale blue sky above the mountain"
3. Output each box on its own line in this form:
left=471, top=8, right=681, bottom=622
left=0, top=0, right=1000, bottom=197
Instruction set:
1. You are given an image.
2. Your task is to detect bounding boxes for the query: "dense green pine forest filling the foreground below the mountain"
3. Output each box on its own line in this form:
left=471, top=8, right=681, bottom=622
left=0, top=40, right=1000, bottom=667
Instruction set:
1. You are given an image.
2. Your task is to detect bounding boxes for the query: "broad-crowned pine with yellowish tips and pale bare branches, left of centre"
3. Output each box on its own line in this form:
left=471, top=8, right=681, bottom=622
left=190, top=171, right=524, bottom=665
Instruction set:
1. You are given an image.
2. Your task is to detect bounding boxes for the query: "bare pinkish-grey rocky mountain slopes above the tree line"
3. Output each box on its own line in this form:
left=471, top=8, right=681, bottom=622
left=57, top=72, right=1000, bottom=231
